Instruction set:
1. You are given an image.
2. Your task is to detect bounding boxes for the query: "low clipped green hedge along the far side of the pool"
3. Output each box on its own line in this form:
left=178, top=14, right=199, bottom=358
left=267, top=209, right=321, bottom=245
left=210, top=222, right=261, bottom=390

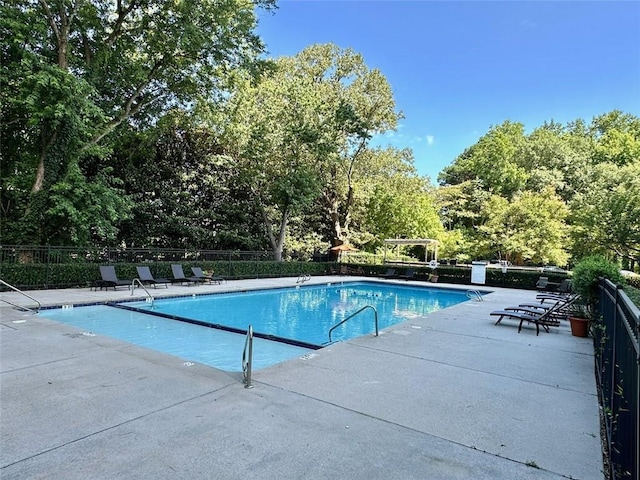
left=0, top=260, right=566, bottom=290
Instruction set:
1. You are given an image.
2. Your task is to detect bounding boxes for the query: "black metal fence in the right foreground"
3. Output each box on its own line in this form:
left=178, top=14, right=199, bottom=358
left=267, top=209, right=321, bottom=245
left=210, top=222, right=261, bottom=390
left=594, top=279, right=640, bottom=480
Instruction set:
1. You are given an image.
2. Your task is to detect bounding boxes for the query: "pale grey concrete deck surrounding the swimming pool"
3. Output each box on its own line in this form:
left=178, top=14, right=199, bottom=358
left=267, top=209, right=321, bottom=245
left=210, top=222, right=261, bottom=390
left=0, top=277, right=603, bottom=480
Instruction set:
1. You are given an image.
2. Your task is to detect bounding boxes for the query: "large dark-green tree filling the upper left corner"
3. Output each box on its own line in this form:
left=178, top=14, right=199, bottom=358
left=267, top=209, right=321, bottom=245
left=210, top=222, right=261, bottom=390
left=0, top=0, right=273, bottom=243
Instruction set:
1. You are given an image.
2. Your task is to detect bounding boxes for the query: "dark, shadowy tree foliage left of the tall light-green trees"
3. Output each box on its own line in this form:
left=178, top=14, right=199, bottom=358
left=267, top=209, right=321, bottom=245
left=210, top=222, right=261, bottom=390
left=115, top=114, right=266, bottom=250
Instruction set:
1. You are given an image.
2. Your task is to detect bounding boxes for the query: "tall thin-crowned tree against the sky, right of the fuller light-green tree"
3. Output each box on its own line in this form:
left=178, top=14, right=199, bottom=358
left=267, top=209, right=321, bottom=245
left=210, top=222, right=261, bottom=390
left=299, top=44, right=402, bottom=241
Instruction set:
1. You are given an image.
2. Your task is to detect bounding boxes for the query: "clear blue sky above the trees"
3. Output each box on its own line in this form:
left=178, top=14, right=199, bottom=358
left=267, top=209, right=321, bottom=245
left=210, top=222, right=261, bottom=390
left=258, top=0, right=640, bottom=182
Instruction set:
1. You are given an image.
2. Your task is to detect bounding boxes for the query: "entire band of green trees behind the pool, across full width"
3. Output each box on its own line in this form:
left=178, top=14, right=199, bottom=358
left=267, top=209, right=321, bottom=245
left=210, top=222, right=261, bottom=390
left=0, top=0, right=640, bottom=267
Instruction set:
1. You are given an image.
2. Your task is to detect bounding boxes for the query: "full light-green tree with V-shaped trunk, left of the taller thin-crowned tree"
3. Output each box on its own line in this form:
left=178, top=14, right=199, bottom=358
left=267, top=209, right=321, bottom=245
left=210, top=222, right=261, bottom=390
left=222, top=59, right=324, bottom=261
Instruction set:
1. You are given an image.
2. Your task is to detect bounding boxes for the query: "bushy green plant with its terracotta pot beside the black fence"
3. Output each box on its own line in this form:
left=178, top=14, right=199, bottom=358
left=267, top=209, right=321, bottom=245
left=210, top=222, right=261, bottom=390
left=569, top=255, right=624, bottom=337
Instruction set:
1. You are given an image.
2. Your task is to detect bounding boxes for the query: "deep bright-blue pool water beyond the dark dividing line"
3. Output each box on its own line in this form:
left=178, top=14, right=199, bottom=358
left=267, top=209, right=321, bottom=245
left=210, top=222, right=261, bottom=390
left=127, top=282, right=468, bottom=345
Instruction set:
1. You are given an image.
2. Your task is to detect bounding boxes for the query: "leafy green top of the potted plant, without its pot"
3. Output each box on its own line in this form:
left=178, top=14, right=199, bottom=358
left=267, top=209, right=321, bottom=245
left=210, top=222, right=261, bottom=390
left=571, top=255, right=624, bottom=315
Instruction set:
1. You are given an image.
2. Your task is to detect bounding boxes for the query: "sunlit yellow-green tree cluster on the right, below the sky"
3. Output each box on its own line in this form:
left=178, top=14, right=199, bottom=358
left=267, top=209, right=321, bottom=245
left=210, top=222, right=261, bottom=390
left=438, top=110, right=640, bottom=265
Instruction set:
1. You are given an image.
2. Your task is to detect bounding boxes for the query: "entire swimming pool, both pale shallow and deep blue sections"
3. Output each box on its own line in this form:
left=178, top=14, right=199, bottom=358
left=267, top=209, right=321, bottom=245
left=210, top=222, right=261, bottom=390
left=36, top=282, right=476, bottom=371
